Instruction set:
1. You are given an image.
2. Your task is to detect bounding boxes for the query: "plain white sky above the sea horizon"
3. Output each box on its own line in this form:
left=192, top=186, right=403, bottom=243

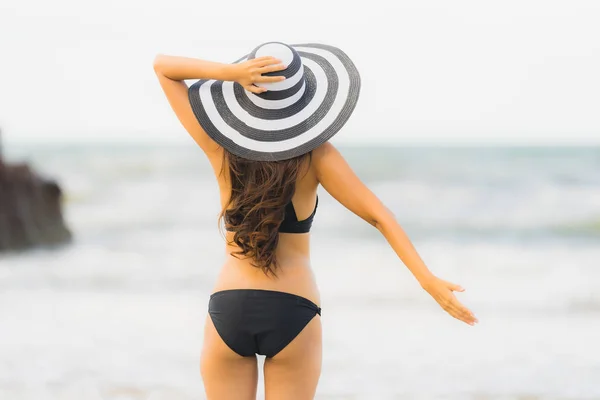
left=0, top=0, right=600, bottom=144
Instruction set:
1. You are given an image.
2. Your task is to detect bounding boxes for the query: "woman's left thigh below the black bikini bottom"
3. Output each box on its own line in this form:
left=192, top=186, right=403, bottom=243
left=200, top=316, right=258, bottom=400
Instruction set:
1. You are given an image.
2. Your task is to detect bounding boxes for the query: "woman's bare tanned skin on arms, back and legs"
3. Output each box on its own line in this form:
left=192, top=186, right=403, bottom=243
left=154, top=55, right=478, bottom=400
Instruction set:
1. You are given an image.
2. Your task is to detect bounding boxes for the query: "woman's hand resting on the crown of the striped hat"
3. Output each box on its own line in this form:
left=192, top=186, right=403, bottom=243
left=231, top=56, right=287, bottom=93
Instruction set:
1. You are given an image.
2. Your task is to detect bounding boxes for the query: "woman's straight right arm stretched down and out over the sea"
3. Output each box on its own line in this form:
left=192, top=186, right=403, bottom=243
left=313, top=143, right=477, bottom=325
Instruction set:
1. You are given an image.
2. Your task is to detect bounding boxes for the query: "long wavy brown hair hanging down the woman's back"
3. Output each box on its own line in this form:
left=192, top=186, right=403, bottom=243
left=219, top=150, right=312, bottom=276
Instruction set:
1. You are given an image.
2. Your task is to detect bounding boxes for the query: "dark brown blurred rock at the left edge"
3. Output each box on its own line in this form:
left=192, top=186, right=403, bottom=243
left=0, top=133, right=71, bottom=252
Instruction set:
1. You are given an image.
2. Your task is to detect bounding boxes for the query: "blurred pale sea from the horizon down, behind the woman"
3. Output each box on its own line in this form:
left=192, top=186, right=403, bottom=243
left=0, top=142, right=600, bottom=400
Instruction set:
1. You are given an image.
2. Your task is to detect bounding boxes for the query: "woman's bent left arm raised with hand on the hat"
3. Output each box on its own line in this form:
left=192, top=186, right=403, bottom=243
left=154, top=54, right=285, bottom=155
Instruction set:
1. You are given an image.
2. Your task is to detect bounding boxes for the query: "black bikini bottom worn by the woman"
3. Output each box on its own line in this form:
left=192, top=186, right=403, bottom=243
left=208, top=289, right=321, bottom=357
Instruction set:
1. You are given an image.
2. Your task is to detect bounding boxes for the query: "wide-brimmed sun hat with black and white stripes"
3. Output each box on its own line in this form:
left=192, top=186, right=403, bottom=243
left=188, top=42, right=360, bottom=161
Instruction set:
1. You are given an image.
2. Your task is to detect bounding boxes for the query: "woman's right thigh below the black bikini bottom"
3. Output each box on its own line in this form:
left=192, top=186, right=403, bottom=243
left=264, top=315, right=322, bottom=400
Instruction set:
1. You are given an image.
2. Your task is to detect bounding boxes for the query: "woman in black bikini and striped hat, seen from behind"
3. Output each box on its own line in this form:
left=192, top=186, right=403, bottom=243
left=154, top=42, right=477, bottom=400
